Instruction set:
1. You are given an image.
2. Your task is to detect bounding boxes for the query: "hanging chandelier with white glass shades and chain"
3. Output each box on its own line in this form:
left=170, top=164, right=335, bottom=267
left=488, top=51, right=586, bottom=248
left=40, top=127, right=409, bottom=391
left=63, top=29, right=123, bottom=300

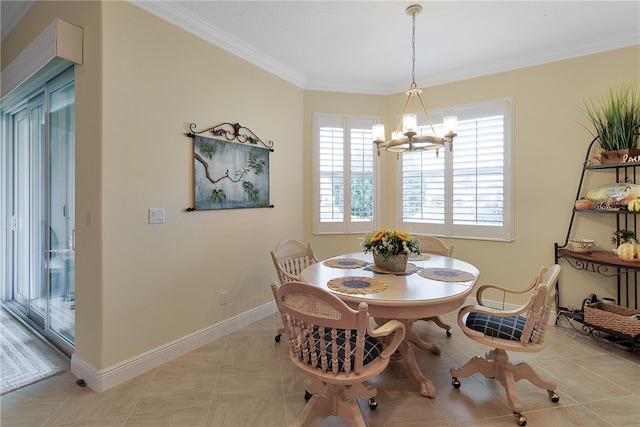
left=373, top=4, right=458, bottom=155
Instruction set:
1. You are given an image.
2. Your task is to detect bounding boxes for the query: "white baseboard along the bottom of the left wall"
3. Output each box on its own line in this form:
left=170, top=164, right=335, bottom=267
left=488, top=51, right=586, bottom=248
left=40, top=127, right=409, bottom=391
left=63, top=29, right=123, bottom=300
left=71, top=301, right=277, bottom=392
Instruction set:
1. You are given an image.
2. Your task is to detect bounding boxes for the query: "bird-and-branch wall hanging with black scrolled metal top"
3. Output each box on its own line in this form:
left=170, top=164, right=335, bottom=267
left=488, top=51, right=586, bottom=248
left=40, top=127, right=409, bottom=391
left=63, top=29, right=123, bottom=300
left=187, top=123, right=274, bottom=212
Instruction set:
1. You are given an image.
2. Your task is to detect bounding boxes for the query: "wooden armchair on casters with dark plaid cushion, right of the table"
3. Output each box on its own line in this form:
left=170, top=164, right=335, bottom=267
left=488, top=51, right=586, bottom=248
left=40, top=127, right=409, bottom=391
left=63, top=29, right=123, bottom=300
left=450, top=264, right=560, bottom=426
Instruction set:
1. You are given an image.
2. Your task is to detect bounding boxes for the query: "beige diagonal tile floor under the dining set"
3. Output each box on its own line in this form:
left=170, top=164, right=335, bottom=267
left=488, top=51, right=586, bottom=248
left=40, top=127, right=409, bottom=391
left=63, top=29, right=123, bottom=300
left=0, top=314, right=640, bottom=427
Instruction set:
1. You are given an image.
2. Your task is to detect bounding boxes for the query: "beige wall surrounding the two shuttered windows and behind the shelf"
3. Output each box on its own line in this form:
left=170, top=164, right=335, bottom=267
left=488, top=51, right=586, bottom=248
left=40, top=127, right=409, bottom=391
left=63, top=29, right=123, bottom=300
left=304, top=46, right=640, bottom=305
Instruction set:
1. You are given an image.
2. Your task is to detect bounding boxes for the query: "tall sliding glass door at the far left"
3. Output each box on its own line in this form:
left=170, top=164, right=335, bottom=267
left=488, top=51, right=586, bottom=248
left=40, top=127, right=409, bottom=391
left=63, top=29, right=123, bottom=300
left=3, top=68, right=75, bottom=354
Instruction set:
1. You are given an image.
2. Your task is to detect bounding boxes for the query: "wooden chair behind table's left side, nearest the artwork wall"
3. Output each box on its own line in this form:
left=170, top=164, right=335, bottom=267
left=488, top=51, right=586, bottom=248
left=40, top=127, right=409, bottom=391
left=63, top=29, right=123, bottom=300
left=271, top=239, right=318, bottom=342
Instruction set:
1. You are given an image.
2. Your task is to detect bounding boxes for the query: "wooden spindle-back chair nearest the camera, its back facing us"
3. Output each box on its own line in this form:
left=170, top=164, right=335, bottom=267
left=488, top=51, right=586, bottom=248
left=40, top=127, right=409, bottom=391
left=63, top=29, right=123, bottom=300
left=271, top=282, right=405, bottom=426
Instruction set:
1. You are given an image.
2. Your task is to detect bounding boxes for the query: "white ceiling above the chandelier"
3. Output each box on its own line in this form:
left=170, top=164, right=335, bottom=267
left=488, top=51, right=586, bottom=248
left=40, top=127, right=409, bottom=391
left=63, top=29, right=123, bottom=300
left=2, top=0, right=640, bottom=94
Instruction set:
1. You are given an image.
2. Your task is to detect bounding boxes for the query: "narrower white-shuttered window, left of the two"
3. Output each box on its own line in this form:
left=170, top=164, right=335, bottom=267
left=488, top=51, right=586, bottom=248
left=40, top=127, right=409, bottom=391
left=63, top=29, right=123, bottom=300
left=313, top=114, right=378, bottom=234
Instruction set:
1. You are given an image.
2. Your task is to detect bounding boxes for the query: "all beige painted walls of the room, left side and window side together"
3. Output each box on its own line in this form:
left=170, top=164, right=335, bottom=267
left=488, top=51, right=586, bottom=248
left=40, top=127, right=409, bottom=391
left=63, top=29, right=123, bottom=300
left=2, top=2, right=640, bottom=378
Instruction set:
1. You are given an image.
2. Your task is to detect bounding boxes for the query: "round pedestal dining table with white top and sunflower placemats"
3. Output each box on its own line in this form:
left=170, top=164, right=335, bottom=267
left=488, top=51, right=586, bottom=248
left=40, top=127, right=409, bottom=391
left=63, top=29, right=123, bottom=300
left=301, top=252, right=480, bottom=398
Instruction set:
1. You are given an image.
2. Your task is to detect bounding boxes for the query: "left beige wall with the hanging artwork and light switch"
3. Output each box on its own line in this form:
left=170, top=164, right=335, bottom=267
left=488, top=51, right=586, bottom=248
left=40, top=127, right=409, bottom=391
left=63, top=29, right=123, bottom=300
left=2, top=2, right=303, bottom=370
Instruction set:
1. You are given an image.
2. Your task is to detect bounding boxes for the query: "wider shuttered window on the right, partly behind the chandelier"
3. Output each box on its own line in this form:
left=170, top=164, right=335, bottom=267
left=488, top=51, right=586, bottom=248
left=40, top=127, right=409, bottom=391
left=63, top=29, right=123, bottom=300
left=398, top=99, right=513, bottom=241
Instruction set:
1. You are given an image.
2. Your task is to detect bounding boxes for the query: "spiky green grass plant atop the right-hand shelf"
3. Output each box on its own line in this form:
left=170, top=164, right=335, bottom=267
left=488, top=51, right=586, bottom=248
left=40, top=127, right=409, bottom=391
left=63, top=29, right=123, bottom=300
left=584, top=85, right=640, bottom=151
